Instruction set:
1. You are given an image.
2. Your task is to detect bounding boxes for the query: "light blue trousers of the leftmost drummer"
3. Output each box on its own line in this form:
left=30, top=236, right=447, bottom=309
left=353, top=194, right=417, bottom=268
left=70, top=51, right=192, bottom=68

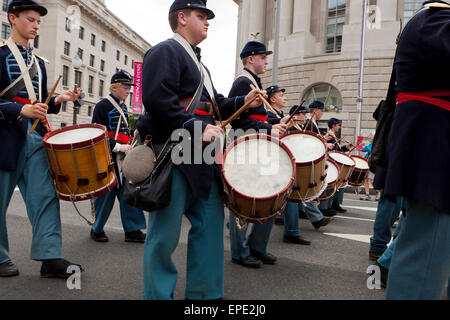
left=0, top=121, right=62, bottom=264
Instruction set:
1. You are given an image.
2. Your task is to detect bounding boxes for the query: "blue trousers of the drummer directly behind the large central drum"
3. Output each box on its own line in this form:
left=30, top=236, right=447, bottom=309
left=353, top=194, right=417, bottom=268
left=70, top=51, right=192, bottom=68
left=230, top=208, right=274, bottom=260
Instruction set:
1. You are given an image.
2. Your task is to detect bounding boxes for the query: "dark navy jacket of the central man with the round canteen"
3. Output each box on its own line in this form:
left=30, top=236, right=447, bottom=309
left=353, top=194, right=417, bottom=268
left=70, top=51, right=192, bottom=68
left=137, top=39, right=245, bottom=199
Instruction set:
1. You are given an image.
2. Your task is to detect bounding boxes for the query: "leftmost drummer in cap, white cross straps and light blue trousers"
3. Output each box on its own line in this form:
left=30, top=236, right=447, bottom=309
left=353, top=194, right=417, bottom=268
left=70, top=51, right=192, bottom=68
left=0, top=0, right=83, bottom=278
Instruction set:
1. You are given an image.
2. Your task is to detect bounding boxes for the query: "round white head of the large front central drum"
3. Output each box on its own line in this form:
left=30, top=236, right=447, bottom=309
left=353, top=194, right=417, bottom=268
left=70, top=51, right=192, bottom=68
left=223, top=135, right=295, bottom=199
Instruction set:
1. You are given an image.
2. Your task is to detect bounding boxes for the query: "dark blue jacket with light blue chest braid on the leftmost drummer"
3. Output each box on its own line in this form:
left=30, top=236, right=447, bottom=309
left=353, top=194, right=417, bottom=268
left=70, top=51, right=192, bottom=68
left=0, top=46, right=61, bottom=171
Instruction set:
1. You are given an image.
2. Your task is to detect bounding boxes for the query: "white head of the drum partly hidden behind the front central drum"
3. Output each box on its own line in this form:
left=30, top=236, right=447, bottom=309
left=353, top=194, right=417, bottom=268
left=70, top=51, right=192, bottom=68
left=281, top=132, right=326, bottom=163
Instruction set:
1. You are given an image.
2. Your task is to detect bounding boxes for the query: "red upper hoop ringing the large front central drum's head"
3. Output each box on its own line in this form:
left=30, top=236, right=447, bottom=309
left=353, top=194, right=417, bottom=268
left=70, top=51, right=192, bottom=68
left=220, top=133, right=297, bottom=200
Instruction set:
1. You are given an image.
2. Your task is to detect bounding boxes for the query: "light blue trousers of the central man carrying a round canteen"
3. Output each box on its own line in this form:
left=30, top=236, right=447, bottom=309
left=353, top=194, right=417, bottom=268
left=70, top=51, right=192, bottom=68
left=143, top=168, right=224, bottom=300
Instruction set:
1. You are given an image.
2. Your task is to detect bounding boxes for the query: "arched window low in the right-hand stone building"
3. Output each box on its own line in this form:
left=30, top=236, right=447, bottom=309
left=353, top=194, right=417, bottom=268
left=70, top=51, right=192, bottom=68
left=302, top=83, right=342, bottom=112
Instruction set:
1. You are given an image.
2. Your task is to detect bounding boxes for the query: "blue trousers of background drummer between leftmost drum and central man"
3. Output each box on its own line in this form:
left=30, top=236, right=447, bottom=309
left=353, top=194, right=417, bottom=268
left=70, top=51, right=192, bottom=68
left=92, top=182, right=147, bottom=233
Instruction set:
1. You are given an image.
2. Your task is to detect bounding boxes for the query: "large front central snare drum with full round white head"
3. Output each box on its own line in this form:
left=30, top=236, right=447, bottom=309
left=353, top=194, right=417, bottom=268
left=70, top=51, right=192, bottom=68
left=221, top=134, right=295, bottom=223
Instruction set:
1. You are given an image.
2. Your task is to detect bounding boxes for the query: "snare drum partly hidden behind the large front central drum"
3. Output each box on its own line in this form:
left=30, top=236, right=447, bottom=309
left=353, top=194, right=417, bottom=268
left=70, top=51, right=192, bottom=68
left=281, top=131, right=327, bottom=202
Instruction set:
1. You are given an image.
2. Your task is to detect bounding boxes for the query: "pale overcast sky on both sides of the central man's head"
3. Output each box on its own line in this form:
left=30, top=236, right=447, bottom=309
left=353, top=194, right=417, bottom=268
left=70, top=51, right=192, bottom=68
left=106, top=0, right=238, bottom=96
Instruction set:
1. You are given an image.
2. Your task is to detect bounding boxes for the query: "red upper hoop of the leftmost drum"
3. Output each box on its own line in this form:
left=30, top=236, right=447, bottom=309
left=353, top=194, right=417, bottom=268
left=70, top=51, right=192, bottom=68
left=42, top=123, right=108, bottom=151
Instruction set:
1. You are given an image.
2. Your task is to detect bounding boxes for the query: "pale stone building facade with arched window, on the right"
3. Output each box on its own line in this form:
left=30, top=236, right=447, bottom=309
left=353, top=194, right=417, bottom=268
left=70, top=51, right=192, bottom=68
left=234, top=0, right=423, bottom=141
